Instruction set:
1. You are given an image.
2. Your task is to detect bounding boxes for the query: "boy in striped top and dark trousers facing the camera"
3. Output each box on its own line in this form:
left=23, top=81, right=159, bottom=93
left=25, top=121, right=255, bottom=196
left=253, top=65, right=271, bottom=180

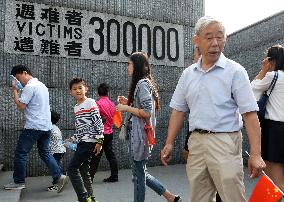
left=66, top=78, right=104, bottom=202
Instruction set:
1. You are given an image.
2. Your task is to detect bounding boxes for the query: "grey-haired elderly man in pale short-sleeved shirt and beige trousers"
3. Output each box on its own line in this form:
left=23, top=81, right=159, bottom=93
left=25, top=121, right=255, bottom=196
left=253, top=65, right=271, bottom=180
left=161, top=16, right=265, bottom=202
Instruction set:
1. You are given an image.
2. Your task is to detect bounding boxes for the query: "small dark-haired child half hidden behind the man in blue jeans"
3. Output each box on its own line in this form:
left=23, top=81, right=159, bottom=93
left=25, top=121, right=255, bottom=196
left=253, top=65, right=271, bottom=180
left=47, top=111, right=66, bottom=191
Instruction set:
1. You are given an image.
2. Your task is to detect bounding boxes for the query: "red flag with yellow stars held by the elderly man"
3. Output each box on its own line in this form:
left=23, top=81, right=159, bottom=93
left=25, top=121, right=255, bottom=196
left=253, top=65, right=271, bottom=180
left=249, top=175, right=283, bottom=202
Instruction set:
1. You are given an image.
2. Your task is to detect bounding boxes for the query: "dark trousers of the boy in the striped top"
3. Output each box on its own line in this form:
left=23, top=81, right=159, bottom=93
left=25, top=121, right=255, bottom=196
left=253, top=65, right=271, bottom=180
left=67, top=142, right=96, bottom=201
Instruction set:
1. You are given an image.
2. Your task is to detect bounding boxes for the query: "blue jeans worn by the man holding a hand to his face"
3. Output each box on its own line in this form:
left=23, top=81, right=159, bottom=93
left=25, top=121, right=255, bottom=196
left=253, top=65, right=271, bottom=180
left=13, top=129, right=62, bottom=184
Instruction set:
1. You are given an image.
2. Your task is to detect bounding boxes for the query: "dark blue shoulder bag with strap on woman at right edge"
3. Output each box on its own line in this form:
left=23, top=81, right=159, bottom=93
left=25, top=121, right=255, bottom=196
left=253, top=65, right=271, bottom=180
left=257, top=71, right=278, bottom=119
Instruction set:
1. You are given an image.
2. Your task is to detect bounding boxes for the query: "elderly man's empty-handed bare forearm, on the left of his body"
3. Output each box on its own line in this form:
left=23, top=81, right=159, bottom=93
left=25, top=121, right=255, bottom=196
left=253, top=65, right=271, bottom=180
left=161, top=109, right=185, bottom=165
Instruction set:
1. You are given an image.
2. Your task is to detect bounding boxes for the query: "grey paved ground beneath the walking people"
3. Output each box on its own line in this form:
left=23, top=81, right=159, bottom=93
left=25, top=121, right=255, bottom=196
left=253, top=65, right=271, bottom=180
left=0, top=164, right=257, bottom=202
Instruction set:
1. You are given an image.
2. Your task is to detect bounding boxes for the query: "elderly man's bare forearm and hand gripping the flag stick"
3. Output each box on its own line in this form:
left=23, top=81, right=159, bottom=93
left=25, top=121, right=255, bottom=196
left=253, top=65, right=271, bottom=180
left=243, top=112, right=266, bottom=178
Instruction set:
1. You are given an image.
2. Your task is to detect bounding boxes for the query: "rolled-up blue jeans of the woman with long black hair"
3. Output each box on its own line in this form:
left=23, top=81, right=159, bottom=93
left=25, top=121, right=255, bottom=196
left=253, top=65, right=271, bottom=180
left=132, top=160, right=166, bottom=202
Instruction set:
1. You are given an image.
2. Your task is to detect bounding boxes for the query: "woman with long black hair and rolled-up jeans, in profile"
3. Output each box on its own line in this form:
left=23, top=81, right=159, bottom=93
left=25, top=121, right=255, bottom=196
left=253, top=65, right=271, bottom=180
left=116, top=52, right=181, bottom=202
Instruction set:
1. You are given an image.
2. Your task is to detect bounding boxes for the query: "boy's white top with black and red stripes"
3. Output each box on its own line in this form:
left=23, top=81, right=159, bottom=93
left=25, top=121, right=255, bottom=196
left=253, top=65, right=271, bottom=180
left=71, top=98, right=104, bottom=143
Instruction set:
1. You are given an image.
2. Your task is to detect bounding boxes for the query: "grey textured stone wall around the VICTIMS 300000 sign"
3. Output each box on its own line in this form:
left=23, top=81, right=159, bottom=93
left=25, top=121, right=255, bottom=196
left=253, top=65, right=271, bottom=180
left=0, top=0, right=204, bottom=176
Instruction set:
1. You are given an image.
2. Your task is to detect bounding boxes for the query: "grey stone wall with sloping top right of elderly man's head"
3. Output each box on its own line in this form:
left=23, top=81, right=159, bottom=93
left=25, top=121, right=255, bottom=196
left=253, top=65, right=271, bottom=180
left=225, top=11, right=284, bottom=162
